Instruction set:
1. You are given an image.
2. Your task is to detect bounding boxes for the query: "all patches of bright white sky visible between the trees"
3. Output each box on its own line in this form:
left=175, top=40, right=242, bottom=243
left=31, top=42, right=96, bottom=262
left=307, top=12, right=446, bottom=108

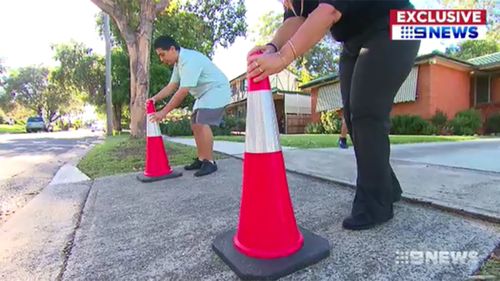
left=0, top=0, right=464, bottom=79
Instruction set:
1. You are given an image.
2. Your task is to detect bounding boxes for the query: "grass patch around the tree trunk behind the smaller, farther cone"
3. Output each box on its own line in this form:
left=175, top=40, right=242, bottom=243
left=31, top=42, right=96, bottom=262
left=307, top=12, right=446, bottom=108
left=78, top=134, right=223, bottom=178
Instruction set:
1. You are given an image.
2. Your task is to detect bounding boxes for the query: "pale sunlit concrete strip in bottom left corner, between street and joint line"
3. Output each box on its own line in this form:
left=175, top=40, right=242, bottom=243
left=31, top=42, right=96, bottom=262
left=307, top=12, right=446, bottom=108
left=0, top=181, right=91, bottom=281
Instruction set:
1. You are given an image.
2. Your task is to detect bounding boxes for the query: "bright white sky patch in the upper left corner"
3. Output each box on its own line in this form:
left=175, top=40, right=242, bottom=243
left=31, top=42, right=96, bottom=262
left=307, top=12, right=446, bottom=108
left=0, top=0, right=105, bottom=67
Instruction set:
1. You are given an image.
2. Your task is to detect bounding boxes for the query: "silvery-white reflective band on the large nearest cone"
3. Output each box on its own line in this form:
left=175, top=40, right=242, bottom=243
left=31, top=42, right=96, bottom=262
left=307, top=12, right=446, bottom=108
left=245, top=90, right=281, bottom=153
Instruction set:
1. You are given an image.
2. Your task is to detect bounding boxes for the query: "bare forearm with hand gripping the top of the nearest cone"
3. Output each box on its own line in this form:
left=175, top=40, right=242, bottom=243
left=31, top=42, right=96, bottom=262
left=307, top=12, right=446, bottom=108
left=247, top=3, right=342, bottom=82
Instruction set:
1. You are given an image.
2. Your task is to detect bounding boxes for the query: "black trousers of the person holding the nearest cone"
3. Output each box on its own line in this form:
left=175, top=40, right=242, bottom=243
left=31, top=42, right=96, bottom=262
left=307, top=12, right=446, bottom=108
left=340, top=22, right=420, bottom=220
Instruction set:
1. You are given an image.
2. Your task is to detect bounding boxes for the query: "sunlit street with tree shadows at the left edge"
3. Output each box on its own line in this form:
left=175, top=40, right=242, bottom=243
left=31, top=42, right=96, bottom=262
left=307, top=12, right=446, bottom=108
left=0, top=130, right=100, bottom=225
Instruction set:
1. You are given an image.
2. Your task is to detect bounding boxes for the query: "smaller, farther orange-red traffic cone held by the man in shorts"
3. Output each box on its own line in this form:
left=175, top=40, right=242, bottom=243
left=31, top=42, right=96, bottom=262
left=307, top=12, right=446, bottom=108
left=137, top=101, right=182, bottom=182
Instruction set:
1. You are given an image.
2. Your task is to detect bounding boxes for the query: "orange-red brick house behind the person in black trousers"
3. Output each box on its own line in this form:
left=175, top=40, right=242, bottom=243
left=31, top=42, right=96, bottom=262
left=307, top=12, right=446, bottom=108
left=300, top=52, right=500, bottom=128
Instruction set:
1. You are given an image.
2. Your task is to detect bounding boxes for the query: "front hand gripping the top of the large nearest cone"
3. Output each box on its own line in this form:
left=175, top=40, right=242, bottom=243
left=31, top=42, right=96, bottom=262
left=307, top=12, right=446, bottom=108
left=247, top=52, right=289, bottom=83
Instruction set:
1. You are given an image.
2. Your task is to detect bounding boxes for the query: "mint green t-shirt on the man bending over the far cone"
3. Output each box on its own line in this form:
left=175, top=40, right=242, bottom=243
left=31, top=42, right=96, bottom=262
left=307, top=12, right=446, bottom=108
left=170, top=48, right=231, bottom=110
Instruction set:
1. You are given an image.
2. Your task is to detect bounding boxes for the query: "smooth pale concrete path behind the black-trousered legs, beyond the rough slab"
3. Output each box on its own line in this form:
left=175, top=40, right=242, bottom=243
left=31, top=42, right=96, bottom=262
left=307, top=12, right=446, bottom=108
left=168, top=138, right=500, bottom=223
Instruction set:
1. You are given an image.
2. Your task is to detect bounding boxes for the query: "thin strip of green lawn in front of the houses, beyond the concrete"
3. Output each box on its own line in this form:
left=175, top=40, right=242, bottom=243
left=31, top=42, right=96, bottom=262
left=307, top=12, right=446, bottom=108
left=215, top=135, right=478, bottom=148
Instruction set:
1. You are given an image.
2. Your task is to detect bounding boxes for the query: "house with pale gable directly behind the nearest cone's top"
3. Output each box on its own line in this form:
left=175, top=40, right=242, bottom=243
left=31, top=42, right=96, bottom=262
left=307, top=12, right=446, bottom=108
left=226, top=70, right=311, bottom=134
